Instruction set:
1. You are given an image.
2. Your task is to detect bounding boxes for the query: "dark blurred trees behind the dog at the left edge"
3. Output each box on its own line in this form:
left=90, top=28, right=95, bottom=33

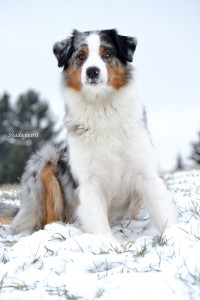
left=0, top=90, right=57, bottom=184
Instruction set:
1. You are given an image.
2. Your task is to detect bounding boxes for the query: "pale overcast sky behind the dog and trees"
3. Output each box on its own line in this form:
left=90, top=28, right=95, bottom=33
left=0, top=0, right=200, bottom=170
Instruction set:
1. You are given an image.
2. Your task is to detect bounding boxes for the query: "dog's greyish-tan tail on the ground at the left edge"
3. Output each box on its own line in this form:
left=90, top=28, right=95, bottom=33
left=0, top=202, right=19, bottom=224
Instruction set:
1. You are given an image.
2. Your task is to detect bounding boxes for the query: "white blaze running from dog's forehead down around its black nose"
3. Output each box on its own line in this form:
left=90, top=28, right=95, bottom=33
left=81, top=33, right=108, bottom=86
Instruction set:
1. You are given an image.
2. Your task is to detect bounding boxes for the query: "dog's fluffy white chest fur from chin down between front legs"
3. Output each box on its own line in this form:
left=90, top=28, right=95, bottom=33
left=65, top=88, right=147, bottom=211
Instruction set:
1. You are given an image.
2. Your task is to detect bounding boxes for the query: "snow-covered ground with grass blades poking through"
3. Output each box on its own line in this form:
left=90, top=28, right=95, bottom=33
left=0, top=171, right=200, bottom=300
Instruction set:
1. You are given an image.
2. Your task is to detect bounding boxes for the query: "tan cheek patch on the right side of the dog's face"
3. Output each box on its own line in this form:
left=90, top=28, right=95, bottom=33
left=107, top=61, right=127, bottom=90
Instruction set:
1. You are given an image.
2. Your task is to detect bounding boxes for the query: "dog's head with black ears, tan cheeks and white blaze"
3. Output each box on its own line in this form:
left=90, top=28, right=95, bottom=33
left=53, top=29, right=136, bottom=95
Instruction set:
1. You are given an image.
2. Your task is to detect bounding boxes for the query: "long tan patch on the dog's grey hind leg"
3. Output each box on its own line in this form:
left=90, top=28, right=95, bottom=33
left=41, top=162, right=64, bottom=225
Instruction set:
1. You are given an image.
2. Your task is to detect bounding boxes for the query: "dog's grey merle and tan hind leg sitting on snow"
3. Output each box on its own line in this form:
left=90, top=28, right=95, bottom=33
left=5, top=145, right=65, bottom=234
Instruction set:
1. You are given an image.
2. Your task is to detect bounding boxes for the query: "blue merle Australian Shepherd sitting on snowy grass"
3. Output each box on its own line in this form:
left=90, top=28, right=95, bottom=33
left=0, top=29, right=176, bottom=246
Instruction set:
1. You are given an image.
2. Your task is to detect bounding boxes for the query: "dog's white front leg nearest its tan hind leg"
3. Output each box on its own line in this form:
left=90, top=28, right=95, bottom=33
left=76, top=183, right=114, bottom=240
